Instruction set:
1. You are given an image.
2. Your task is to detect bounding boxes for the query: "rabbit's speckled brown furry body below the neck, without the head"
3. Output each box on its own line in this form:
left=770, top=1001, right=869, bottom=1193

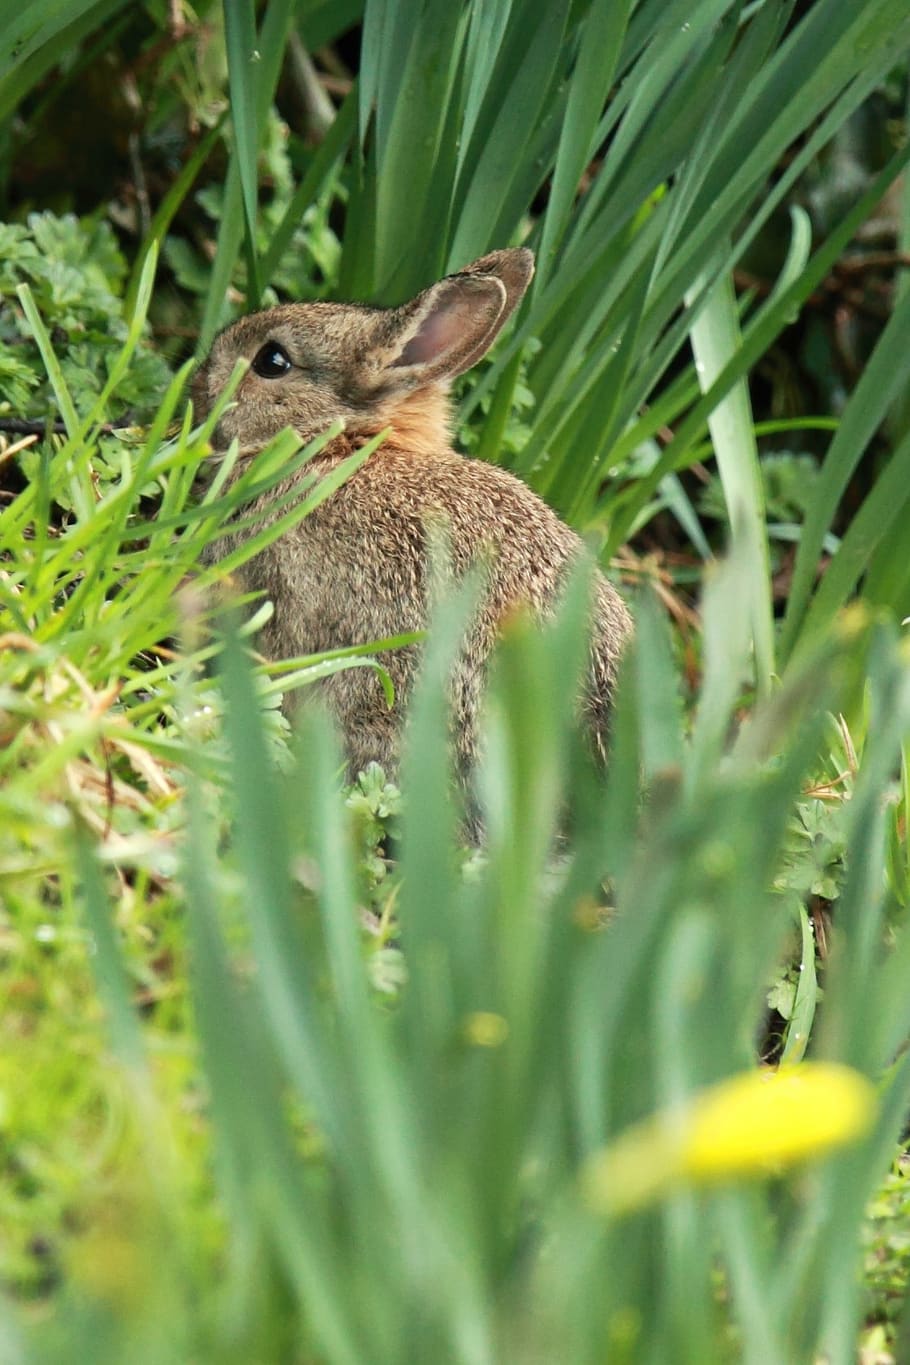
left=231, top=445, right=629, bottom=773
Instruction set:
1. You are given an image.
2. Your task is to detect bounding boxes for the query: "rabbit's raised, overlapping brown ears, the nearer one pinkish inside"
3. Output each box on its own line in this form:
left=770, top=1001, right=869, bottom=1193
left=385, top=250, right=533, bottom=388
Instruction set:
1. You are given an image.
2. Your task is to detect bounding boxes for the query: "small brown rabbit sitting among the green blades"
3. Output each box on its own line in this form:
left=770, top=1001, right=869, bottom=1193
left=192, top=250, right=630, bottom=779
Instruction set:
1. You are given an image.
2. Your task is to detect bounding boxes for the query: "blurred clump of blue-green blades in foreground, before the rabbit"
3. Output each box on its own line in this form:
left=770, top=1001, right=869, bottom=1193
left=8, top=566, right=910, bottom=1361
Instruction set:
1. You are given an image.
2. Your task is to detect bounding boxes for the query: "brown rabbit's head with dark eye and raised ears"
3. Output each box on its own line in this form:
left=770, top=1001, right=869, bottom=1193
left=192, top=248, right=533, bottom=452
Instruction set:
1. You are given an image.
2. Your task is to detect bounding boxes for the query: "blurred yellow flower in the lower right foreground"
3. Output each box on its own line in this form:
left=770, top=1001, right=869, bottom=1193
left=583, top=1062, right=877, bottom=1215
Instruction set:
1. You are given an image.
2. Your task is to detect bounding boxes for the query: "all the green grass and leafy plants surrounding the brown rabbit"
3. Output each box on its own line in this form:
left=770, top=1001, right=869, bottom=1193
left=0, top=0, right=910, bottom=1365
